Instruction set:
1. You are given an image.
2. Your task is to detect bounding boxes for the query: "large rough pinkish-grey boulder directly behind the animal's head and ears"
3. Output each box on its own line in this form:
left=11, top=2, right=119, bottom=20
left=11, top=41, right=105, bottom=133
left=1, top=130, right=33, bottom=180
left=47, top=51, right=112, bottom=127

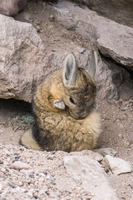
left=0, top=15, right=118, bottom=102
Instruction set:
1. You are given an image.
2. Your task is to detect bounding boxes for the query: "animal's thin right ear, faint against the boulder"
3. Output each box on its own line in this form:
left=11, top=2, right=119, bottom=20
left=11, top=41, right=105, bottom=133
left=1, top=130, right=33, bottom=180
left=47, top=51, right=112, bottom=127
left=87, top=51, right=98, bottom=78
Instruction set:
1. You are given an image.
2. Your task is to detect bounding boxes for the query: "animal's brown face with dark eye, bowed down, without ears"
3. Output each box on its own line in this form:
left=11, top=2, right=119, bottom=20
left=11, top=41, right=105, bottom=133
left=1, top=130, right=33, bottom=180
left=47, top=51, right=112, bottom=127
left=63, top=68, right=96, bottom=119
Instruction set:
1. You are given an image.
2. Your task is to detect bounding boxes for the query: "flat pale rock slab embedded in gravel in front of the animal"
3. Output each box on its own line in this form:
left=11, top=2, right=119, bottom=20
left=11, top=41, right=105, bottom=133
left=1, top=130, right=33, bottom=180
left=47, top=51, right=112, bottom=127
left=64, top=156, right=118, bottom=200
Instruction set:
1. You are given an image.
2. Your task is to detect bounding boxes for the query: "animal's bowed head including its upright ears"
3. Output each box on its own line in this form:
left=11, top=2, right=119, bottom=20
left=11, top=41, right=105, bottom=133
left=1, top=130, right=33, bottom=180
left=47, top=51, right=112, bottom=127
left=51, top=54, right=96, bottom=119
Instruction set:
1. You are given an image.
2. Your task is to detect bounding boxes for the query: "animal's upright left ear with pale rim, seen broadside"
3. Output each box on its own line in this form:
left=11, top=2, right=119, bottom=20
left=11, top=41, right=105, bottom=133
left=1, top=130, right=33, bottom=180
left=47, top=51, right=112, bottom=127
left=63, top=53, right=77, bottom=87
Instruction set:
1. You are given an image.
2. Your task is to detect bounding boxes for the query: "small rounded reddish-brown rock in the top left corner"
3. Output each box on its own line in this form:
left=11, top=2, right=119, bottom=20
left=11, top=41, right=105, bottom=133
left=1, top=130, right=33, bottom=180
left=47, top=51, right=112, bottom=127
left=0, top=0, right=27, bottom=16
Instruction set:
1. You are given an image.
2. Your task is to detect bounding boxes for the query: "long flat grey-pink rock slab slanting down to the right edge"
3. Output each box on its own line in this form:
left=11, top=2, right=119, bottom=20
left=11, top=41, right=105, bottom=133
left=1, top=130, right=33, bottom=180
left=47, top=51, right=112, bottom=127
left=54, top=1, right=133, bottom=70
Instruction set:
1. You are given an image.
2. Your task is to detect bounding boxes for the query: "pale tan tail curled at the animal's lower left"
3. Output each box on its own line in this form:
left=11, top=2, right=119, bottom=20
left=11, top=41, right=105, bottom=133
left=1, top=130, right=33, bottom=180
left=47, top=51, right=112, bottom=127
left=20, top=128, right=42, bottom=151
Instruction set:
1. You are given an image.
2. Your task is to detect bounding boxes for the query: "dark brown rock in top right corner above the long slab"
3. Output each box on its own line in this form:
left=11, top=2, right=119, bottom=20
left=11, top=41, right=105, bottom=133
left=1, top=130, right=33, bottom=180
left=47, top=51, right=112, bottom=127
left=72, top=0, right=133, bottom=26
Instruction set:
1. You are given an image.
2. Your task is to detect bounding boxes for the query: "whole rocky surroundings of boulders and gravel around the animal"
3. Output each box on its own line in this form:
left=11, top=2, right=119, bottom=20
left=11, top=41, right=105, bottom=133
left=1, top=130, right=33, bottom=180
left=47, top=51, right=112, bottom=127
left=0, top=0, right=133, bottom=200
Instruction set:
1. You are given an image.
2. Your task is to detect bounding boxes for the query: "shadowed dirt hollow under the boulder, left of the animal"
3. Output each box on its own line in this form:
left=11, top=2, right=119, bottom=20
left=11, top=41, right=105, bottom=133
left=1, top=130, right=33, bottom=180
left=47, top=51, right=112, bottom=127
left=0, top=99, right=33, bottom=145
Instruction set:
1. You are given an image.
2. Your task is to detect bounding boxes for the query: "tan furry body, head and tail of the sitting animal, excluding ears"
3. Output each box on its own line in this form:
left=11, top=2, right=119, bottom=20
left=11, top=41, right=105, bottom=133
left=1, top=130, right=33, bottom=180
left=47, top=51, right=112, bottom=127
left=21, top=52, right=101, bottom=152
